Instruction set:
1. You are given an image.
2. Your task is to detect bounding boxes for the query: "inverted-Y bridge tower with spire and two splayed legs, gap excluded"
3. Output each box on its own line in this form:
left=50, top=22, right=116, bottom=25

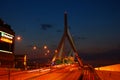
left=52, top=12, right=83, bottom=67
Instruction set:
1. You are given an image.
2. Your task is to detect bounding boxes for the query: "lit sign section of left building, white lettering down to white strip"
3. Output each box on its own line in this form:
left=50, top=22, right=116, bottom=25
left=0, top=31, right=14, bottom=53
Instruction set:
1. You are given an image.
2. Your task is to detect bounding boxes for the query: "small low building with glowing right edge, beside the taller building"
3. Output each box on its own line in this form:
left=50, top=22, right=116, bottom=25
left=15, top=54, right=27, bottom=70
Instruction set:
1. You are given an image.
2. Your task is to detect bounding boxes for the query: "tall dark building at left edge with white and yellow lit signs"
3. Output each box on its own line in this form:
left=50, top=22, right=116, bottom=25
left=0, top=19, right=15, bottom=68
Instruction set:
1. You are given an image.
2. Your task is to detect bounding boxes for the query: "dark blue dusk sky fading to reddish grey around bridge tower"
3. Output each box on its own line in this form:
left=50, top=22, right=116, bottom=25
left=0, top=0, right=120, bottom=65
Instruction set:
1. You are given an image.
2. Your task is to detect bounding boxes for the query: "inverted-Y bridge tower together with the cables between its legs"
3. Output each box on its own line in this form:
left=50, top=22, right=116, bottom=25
left=52, top=12, right=83, bottom=67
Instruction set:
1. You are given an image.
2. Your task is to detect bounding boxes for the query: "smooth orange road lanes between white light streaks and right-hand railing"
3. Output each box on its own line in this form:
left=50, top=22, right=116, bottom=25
left=26, top=65, right=82, bottom=80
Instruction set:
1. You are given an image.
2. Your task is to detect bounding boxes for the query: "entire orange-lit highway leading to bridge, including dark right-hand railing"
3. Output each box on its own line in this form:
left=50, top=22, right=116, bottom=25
left=0, top=64, right=101, bottom=80
